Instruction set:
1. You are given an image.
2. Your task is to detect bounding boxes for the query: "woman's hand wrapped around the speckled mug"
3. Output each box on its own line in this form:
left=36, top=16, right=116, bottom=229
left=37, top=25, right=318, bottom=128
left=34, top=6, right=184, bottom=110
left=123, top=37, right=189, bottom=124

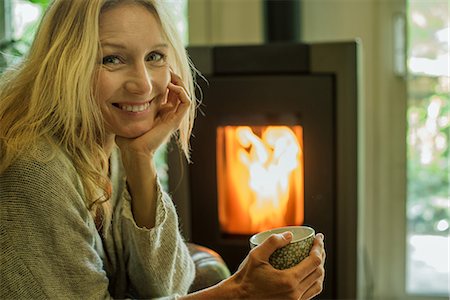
left=232, top=232, right=326, bottom=299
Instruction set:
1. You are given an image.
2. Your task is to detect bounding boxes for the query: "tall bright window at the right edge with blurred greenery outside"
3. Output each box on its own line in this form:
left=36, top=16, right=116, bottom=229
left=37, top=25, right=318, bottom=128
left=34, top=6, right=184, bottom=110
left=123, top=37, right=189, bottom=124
left=406, top=0, right=450, bottom=296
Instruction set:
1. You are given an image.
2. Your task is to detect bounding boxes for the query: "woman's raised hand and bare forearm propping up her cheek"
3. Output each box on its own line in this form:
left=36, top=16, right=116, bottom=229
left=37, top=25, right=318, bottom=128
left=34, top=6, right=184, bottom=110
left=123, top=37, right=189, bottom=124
left=116, top=71, right=191, bottom=229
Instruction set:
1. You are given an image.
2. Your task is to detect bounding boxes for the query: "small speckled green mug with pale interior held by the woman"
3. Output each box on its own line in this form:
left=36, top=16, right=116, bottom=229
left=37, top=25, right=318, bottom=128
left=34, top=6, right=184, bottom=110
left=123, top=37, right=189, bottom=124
left=250, top=226, right=315, bottom=270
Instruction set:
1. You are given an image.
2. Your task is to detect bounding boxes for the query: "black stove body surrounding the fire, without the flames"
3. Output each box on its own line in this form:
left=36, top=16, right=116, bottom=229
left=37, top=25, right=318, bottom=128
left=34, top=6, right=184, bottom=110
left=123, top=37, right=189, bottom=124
left=169, top=42, right=359, bottom=299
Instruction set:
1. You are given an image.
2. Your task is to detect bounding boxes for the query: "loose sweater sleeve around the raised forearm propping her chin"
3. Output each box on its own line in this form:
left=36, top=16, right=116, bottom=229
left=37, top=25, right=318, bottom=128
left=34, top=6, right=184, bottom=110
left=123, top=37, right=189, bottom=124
left=121, top=183, right=195, bottom=298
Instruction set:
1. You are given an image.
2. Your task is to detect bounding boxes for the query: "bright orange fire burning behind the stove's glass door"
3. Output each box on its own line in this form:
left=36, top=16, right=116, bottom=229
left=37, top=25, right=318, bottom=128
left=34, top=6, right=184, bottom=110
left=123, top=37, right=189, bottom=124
left=217, top=126, right=303, bottom=234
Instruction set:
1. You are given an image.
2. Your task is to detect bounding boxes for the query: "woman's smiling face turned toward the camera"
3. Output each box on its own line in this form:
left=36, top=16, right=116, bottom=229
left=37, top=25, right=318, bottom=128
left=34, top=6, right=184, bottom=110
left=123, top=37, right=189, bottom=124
left=95, top=4, right=170, bottom=138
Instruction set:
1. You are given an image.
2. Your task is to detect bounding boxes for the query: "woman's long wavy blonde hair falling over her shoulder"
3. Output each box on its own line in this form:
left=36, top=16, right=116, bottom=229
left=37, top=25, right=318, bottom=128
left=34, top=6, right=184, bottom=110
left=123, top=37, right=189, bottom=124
left=0, top=0, right=196, bottom=225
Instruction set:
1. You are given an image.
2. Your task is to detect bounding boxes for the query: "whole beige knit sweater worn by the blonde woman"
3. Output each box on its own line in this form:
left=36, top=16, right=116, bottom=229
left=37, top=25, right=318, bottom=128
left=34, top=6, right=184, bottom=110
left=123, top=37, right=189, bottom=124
left=0, top=145, right=194, bottom=299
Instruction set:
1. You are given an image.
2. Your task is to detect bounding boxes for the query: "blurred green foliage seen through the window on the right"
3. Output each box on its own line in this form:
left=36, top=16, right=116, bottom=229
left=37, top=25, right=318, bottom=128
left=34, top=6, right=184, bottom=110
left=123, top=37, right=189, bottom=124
left=407, top=1, right=450, bottom=236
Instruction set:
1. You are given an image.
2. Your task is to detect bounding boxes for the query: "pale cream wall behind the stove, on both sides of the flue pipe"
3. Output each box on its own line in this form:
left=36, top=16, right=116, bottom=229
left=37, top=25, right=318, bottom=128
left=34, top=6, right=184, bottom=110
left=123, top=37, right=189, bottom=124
left=189, top=0, right=406, bottom=299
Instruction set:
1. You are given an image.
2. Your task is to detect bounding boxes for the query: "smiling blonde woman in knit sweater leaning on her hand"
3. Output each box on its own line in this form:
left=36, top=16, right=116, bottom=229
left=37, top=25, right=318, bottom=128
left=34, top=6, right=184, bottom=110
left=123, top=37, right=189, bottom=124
left=0, top=0, right=325, bottom=299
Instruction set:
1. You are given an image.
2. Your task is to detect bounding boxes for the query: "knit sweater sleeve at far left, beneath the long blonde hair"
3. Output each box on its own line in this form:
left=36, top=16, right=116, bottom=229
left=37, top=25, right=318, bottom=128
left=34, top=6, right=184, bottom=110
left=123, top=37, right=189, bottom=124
left=0, top=154, right=110, bottom=299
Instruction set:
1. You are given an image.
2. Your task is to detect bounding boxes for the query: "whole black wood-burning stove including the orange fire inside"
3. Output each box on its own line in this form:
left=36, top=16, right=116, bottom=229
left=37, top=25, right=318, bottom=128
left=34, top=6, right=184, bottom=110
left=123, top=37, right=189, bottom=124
left=169, top=42, right=358, bottom=299
